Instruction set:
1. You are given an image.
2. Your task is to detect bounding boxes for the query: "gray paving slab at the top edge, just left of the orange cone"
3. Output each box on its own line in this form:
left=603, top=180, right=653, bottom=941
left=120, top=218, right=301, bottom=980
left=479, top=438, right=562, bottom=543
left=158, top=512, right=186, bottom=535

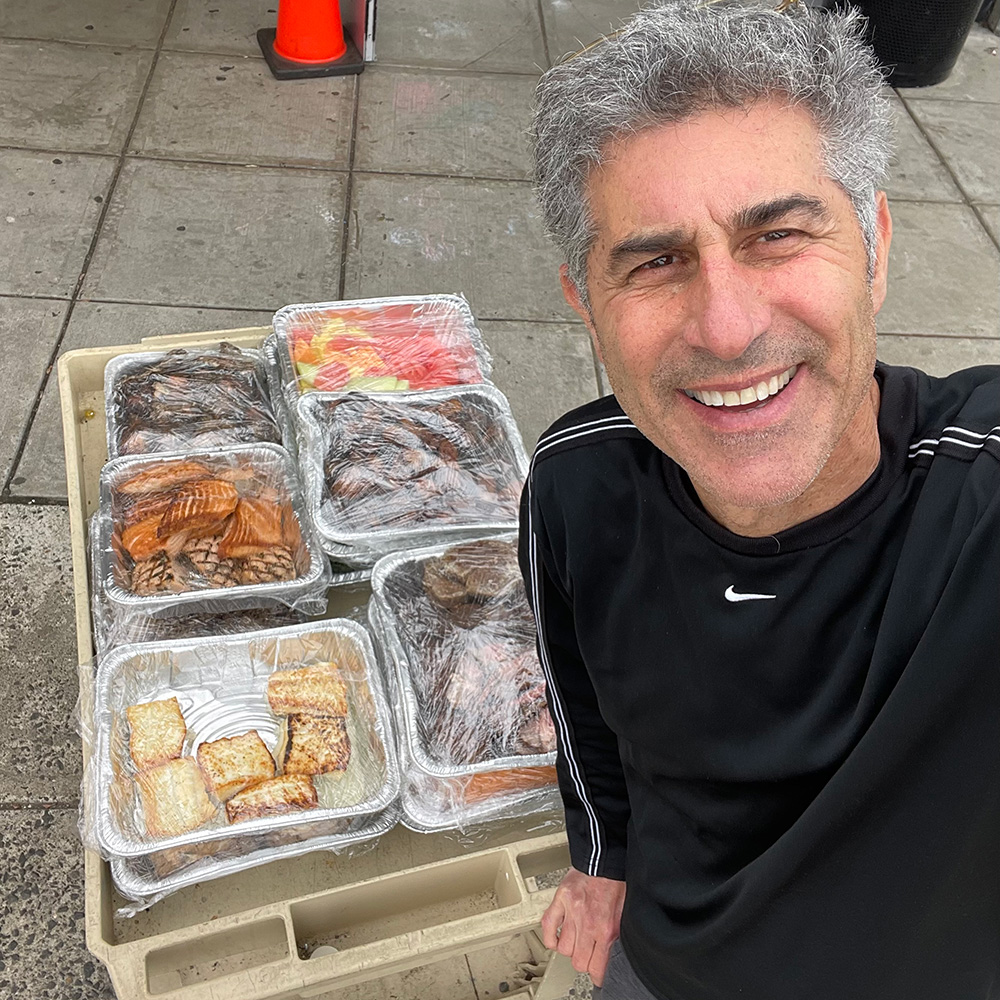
left=163, top=0, right=278, bottom=58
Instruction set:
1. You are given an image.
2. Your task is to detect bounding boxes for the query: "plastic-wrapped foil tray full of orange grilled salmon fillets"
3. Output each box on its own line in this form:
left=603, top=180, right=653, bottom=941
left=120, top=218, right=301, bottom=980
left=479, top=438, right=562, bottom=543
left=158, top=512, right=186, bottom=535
left=97, top=444, right=329, bottom=617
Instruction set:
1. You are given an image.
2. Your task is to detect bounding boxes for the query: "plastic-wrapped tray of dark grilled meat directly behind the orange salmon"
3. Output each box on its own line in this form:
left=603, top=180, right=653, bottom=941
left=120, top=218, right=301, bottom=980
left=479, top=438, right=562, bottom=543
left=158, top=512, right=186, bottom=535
left=104, top=343, right=281, bottom=458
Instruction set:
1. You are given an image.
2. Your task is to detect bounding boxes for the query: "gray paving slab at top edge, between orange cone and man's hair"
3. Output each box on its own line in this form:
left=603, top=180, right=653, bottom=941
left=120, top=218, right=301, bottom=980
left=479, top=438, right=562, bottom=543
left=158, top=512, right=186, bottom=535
left=375, top=0, right=548, bottom=73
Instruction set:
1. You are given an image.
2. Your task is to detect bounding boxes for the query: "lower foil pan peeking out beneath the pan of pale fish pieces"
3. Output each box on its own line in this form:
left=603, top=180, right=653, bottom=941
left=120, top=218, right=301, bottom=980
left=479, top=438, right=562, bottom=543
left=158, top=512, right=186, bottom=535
left=111, top=806, right=399, bottom=901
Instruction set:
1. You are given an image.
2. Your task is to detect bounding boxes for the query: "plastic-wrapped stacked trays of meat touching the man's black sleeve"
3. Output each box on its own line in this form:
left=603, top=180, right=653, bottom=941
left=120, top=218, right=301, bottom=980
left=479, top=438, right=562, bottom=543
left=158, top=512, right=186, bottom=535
left=371, top=537, right=559, bottom=831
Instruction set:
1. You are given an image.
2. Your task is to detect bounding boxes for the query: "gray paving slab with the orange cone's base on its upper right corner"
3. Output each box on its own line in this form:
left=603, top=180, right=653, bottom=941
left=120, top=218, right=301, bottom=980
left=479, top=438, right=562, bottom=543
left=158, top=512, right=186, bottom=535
left=129, top=52, right=355, bottom=169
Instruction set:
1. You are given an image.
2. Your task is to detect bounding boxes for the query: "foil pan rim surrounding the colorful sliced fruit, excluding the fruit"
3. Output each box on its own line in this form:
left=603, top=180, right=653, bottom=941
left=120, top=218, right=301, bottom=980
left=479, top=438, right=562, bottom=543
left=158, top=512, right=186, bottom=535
left=273, top=295, right=492, bottom=396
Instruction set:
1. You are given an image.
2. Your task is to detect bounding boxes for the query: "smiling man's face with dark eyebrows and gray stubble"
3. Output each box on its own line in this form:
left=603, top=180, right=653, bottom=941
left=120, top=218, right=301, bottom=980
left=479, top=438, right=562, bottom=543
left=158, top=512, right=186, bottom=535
left=563, top=103, right=890, bottom=508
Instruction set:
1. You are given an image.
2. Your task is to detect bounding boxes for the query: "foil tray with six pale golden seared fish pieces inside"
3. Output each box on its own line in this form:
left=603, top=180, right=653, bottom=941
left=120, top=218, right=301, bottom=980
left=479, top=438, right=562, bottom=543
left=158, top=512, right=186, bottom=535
left=92, top=619, right=399, bottom=858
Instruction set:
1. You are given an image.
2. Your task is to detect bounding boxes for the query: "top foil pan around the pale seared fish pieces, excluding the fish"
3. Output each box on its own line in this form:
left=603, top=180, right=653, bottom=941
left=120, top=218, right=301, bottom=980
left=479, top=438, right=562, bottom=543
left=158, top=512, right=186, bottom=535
left=94, top=619, right=399, bottom=860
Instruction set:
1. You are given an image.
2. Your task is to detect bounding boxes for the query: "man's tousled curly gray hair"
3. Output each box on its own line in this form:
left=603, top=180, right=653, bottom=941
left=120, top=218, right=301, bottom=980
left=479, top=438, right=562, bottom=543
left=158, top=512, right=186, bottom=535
left=531, top=0, right=892, bottom=308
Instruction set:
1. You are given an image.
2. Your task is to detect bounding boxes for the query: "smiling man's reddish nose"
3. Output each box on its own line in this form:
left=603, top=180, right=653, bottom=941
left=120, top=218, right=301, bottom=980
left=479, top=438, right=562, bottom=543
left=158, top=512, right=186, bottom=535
left=685, top=254, right=771, bottom=361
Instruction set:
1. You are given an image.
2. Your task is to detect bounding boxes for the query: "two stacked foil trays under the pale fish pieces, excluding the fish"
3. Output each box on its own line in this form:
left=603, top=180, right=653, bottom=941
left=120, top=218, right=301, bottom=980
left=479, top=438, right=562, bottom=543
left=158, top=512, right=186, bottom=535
left=84, top=619, right=399, bottom=903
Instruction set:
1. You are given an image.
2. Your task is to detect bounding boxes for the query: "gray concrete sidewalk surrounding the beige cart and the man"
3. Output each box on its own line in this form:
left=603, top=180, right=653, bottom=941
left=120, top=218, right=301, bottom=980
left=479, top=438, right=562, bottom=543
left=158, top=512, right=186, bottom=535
left=0, top=0, right=1000, bottom=1000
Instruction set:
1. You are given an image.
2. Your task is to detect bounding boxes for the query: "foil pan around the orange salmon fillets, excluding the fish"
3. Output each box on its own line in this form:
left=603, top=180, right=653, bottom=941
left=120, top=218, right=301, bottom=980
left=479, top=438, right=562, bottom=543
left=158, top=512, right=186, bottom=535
left=98, top=444, right=330, bottom=617
